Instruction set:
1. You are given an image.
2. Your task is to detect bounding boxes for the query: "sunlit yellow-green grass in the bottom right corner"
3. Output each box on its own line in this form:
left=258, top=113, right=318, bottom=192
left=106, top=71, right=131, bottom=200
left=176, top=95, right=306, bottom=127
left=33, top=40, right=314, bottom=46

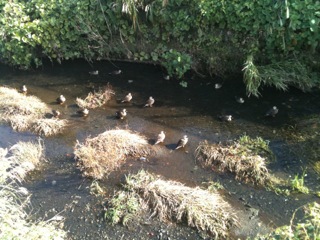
left=255, top=202, right=320, bottom=240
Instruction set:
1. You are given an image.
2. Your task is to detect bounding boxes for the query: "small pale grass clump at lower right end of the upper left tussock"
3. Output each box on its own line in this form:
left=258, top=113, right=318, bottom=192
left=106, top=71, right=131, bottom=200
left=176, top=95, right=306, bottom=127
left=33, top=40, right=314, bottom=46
left=32, top=118, right=68, bottom=136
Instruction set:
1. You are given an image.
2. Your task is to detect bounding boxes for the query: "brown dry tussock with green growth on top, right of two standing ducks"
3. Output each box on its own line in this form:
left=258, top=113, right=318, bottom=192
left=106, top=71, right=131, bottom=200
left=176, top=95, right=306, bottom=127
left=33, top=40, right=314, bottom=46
left=195, top=136, right=274, bottom=186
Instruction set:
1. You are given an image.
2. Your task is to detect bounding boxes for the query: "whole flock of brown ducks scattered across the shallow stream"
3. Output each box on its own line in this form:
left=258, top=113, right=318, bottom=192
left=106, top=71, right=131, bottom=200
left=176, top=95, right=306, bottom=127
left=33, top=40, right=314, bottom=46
left=20, top=69, right=279, bottom=150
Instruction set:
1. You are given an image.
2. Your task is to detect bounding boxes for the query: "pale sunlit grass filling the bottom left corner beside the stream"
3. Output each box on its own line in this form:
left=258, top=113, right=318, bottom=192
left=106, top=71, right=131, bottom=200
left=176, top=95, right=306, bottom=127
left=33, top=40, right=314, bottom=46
left=0, top=142, right=66, bottom=240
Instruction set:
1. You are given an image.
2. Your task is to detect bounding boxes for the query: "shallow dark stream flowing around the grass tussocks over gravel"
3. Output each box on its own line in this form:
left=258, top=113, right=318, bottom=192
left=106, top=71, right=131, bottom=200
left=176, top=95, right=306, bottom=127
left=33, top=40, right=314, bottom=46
left=0, top=61, right=320, bottom=239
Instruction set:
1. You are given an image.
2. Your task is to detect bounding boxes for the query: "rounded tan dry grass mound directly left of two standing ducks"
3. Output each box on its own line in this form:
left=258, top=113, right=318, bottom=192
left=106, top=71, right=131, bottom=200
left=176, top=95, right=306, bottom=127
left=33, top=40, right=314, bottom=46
left=74, top=129, right=151, bottom=179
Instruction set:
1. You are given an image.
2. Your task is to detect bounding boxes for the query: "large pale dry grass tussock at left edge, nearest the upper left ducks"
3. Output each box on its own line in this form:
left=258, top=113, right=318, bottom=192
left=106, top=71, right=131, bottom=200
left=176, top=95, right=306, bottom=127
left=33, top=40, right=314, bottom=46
left=0, top=87, right=67, bottom=136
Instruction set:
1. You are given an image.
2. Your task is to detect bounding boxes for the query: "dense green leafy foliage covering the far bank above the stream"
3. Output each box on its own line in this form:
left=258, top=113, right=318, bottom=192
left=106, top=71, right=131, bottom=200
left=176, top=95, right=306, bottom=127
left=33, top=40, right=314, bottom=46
left=0, top=0, right=320, bottom=95
